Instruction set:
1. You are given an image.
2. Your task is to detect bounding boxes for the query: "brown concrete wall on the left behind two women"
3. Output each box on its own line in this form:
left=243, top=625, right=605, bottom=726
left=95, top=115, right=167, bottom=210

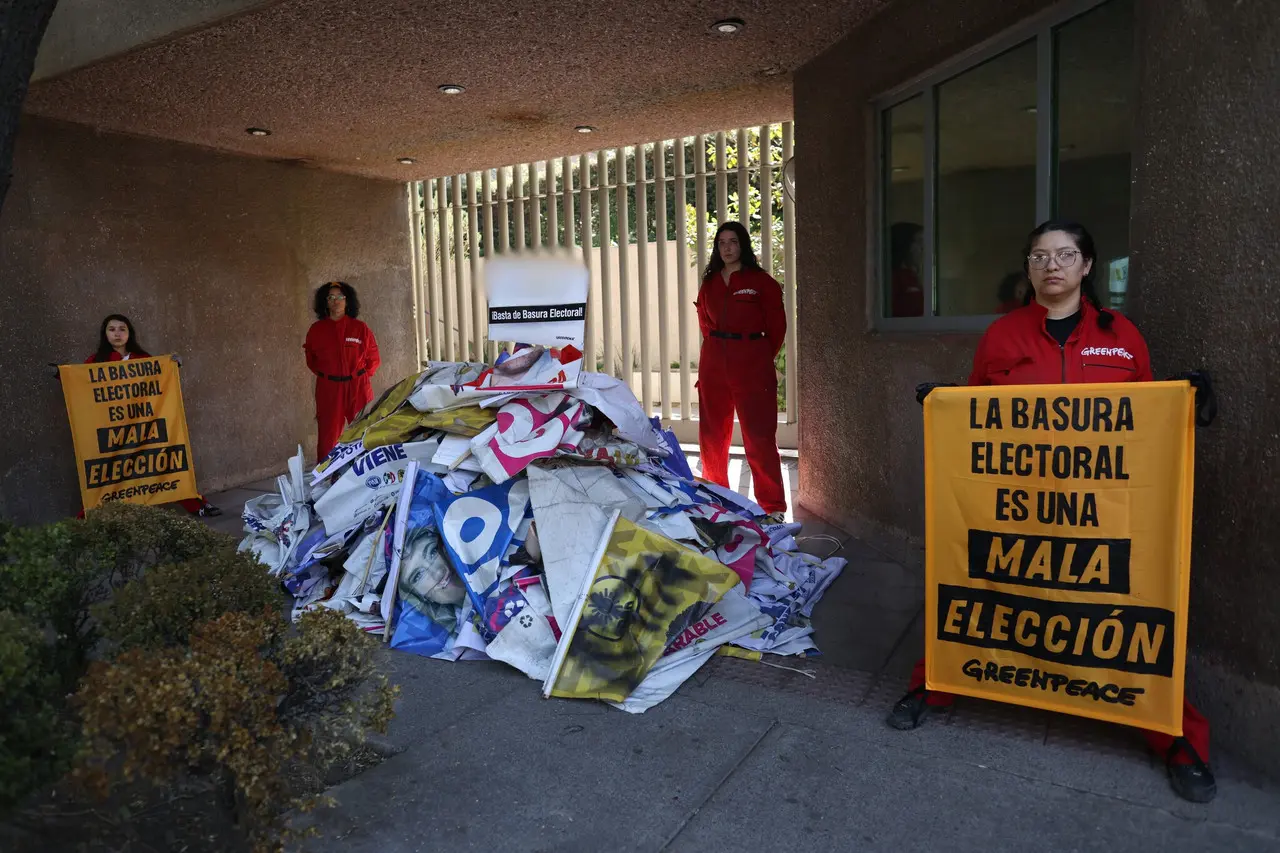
left=0, top=119, right=415, bottom=521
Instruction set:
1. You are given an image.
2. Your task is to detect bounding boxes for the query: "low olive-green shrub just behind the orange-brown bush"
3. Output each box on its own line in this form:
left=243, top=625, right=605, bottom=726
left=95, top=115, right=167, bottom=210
left=93, top=551, right=284, bottom=651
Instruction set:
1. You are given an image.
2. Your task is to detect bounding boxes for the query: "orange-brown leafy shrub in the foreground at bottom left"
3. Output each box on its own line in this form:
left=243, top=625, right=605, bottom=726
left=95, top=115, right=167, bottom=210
left=76, top=610, right=397, bottom=850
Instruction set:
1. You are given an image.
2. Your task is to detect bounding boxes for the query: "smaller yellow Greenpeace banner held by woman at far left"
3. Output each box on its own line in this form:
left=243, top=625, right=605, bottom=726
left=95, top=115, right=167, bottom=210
left=58, top=356, right=198, bottom=510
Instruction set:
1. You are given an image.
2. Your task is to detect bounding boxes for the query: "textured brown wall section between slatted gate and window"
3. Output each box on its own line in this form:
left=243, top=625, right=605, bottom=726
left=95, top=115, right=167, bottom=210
left=795, top=0, right=1048, bottom=560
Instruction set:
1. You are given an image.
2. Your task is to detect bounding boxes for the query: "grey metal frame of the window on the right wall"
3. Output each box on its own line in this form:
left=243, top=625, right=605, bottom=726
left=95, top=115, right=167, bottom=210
left=868, top=0, right=1123, bottom=334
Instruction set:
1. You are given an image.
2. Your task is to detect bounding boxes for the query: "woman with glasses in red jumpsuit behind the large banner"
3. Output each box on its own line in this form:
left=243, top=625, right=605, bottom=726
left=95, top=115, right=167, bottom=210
left=887, top=222, right=1217, bottom=803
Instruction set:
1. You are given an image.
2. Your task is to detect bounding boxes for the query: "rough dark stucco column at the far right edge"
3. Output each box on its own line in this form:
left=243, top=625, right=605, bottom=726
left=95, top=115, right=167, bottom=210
left=1132, top=0, right=1280, bottom=771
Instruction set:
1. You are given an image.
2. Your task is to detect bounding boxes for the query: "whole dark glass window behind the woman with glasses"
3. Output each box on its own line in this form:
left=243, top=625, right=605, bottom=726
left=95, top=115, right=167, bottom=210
left=879, top=0, right=1134, bottom=329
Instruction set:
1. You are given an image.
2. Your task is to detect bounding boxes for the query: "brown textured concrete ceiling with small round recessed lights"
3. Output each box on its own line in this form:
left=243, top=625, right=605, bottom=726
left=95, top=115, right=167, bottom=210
left=27, top=0, right=892, bottom=181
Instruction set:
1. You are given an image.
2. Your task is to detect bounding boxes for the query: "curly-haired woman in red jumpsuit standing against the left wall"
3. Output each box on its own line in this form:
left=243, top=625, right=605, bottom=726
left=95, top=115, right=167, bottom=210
left=303, top=282, right=381, bottom=462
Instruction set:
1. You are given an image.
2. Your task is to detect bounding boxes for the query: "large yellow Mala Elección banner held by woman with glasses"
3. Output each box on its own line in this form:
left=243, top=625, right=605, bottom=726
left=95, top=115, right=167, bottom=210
left=924, top=382, right=1194, bottom=735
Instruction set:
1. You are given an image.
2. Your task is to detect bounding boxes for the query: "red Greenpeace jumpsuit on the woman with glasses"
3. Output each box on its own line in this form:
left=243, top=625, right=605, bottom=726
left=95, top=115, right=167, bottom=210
left=910, top=301, right=1208, bottom=763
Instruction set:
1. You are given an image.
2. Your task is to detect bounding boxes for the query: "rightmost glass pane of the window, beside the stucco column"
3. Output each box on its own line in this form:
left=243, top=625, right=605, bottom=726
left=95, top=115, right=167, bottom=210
left=1056, top=1, right=1134, bottom=310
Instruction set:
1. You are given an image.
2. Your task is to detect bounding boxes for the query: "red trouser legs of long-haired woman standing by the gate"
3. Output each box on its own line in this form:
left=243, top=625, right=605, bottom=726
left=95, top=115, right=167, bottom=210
left=698, top=353, right=787, bottom=512
